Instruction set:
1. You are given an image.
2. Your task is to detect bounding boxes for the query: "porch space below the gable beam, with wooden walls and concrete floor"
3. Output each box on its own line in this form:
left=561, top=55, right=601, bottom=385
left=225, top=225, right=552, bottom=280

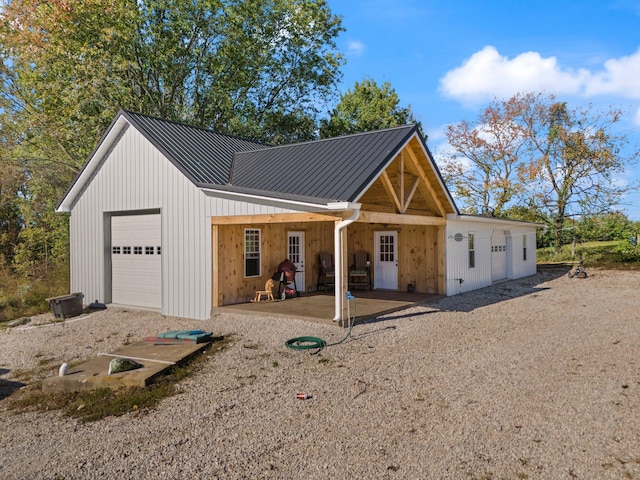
left=212, top=210, right=445, bottom=321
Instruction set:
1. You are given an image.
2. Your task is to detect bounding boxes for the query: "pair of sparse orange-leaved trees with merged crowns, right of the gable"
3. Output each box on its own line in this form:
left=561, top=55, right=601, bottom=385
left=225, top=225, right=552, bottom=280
left=443, top=93, right=639, bottom=247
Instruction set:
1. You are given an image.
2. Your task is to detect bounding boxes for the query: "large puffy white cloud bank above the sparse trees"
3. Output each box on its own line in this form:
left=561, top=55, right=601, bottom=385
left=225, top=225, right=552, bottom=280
left=440, top=46, right=640, bottom=104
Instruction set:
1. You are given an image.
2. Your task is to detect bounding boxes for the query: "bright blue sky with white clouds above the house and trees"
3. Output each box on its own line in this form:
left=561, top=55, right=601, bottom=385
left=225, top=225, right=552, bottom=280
left=328, top=0, right=640, bottom=220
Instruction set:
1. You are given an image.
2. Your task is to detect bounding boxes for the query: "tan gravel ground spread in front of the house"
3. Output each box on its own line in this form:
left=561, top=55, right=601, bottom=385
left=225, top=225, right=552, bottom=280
left=0, top=270, right=640, bottom=479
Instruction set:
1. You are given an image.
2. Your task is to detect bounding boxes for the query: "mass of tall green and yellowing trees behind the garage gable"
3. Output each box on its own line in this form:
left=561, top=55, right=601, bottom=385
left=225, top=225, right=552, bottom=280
left=0, top=0, right=343, bottom=276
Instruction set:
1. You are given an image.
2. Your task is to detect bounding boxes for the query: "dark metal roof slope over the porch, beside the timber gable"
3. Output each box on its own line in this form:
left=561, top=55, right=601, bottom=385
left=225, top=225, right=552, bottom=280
left=230, top=125, right=418, bottom=202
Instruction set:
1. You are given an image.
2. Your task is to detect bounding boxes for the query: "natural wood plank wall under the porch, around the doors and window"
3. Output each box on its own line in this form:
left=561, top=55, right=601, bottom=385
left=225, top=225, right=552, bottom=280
left=212, top=222, right=445, bottom=306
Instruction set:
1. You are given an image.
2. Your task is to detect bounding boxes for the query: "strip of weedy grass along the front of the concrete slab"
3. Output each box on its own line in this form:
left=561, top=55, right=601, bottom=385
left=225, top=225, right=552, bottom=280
left=6, top=336, right=231, bottom=422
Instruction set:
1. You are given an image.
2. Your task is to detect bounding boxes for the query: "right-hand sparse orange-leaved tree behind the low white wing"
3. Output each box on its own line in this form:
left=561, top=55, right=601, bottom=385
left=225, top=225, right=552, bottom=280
left=520, top=94, right=639, bottom=248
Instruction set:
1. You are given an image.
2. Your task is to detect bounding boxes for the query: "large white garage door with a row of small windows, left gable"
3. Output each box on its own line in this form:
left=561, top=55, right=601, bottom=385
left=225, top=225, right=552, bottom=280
left=111, top=214, right=162, bottom=308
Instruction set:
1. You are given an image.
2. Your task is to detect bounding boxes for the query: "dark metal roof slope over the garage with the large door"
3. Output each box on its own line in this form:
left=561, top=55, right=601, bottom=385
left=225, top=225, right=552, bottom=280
left=121, top=111, right=268, bottom=185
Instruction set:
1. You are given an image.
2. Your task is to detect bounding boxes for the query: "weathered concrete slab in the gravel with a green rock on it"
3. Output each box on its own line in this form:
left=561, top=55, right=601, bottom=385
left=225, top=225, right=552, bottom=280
left=42, top=341, right=209, bottom=393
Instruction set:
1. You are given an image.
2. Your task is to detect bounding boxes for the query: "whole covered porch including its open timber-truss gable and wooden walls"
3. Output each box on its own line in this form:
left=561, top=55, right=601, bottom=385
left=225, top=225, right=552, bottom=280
left=211, top=133, right=456, bottom=321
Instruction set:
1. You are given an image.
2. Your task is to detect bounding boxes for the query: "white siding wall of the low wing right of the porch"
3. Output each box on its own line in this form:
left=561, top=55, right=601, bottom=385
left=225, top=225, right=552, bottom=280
left=446, top=215, right=536, bottom=295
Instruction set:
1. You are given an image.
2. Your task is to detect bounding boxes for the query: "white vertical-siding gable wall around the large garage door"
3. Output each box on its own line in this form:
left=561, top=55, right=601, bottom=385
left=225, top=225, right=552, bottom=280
left=70, top=127, right=298, bottom=320
